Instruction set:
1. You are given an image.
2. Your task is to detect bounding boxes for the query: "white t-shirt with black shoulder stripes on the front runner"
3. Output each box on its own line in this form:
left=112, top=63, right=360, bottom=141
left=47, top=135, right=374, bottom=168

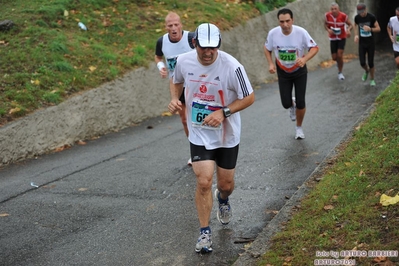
left=173, top=50, right=253, bottom=150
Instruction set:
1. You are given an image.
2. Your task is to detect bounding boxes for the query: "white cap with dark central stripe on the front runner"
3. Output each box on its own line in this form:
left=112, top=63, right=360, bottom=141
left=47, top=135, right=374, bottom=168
left=195, top=23, right=222, bottom=48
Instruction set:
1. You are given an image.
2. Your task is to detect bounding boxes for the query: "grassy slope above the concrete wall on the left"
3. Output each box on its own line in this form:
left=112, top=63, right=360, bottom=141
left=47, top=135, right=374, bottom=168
left=0, top=0, right=292, bottom=126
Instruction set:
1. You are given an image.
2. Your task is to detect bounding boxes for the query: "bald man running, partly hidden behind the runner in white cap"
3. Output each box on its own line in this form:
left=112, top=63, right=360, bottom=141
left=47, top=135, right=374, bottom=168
left=155, top=12, right=194, bottom=165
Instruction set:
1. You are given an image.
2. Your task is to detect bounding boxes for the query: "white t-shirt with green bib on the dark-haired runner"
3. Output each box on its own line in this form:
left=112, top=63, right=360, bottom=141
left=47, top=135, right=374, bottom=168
left=265, top=25, right=317, bottom=73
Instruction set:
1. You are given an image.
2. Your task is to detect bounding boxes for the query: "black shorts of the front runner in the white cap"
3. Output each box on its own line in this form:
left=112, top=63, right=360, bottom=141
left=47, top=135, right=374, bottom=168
left=190, top=143, right=239, bottom=169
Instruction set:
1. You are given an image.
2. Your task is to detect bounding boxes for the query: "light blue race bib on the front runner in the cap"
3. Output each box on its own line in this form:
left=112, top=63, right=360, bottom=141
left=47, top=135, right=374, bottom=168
left=191, top=100, right=223, bottom=129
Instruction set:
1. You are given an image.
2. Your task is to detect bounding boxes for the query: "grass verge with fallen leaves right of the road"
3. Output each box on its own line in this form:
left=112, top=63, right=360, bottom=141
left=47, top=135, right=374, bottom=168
left=258, top=75, right=399, bottom=266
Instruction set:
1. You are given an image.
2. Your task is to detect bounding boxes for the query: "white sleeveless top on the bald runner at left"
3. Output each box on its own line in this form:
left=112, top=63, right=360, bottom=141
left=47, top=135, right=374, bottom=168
left=162, top=31, right=193, bottom=78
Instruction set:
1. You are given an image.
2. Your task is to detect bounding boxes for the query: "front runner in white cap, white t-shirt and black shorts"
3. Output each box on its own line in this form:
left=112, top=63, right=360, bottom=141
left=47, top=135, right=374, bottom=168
left=168, top=23, right=255, bottom=252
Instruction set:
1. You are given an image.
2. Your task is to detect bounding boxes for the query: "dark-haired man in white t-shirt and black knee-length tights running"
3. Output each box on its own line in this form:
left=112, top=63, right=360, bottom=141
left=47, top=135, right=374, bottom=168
left=263, top=8, right=319, bottom=139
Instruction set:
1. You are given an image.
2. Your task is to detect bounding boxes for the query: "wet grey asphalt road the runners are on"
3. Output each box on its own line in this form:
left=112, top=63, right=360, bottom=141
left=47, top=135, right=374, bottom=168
left=0, top=40, right=396, bottom=266
